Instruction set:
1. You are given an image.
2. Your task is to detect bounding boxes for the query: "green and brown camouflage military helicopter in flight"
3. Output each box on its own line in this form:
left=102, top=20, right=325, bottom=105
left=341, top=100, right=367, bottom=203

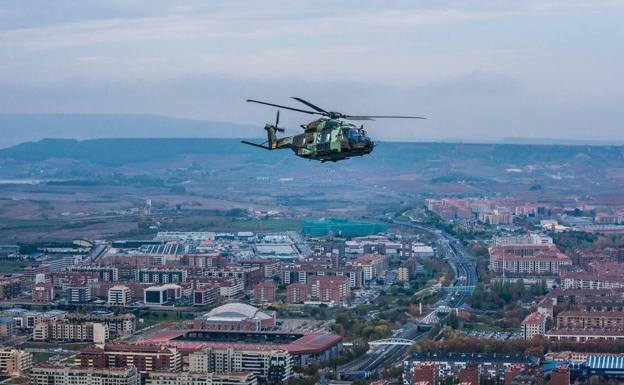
left=242, top=97, right=425, bottom=162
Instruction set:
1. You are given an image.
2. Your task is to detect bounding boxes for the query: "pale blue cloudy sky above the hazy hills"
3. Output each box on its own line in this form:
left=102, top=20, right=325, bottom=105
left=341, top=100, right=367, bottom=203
left=0, top=0, right=624, bottom=141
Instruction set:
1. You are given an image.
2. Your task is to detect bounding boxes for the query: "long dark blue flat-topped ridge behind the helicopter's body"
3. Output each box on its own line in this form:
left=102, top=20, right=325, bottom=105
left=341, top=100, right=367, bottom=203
left=0, top=138, right=624, bottom=169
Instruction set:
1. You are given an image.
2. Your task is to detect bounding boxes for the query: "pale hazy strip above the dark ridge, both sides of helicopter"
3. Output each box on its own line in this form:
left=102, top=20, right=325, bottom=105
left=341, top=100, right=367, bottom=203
left=0, top=113, right=624, bottom=149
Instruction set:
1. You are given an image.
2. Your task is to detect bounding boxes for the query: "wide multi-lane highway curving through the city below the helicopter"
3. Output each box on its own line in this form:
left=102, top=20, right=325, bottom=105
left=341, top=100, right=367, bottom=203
left=338, top=222, right=478, bottom=378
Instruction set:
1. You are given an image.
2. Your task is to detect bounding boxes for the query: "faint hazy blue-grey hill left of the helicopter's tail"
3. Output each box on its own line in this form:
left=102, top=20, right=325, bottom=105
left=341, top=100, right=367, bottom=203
left=0, top=114, right=263, bottom=148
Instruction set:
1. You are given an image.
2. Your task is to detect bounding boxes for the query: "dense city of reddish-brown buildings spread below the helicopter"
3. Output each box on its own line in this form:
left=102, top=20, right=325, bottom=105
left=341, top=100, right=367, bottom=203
left=0, top=198, right=624, bottom=385
